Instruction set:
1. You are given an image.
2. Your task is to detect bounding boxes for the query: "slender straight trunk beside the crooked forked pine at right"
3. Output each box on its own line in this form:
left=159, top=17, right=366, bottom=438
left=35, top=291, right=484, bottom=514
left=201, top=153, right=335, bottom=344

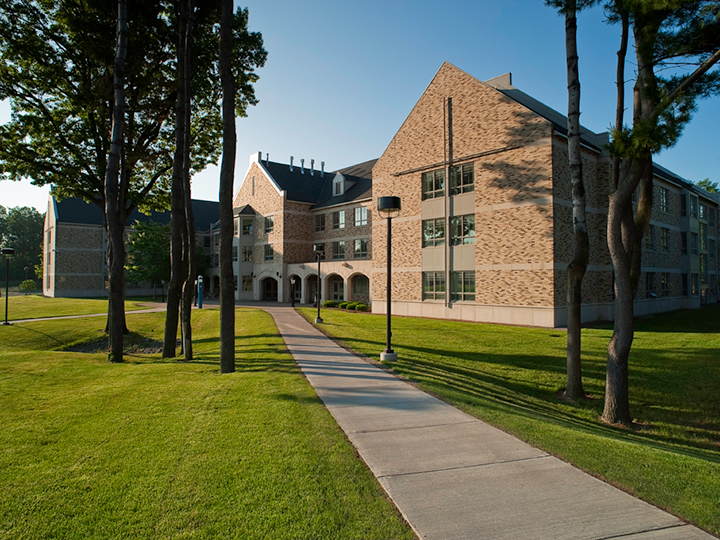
left=565, top=0, right=590, bottom=401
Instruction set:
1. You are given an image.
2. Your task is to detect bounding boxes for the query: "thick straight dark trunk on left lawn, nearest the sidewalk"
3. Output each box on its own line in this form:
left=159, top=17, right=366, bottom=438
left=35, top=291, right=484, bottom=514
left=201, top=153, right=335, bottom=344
left=220, top=0, right=236, bottom=373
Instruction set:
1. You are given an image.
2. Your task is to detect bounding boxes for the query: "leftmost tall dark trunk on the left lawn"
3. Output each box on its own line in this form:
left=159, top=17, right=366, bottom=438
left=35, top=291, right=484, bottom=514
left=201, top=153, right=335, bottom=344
left=105, top=0, right=128, bottom=362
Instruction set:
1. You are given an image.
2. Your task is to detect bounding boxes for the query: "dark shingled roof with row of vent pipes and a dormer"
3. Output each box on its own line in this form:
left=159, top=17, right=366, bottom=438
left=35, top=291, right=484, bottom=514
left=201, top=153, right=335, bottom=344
left=261, top=159, right=377, bottom=209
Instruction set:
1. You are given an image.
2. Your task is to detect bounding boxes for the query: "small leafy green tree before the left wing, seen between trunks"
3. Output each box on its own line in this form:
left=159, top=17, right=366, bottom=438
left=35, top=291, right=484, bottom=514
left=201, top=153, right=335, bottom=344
left=125, top=222, right=170, bottom=296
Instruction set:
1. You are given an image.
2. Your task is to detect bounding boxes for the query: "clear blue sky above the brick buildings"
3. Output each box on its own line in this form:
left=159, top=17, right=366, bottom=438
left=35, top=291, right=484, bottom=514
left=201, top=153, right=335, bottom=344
left=0, top=0, right=720, bottom=211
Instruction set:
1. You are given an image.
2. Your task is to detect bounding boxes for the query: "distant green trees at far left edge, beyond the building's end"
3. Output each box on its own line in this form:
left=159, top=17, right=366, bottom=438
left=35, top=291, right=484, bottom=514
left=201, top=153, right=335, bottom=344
left=0, top=206, right=45, bottom=283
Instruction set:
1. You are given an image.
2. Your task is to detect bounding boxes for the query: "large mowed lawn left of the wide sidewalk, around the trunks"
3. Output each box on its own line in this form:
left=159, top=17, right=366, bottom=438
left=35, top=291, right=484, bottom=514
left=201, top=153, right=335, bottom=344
left=0, top=310, right=415, bottom=540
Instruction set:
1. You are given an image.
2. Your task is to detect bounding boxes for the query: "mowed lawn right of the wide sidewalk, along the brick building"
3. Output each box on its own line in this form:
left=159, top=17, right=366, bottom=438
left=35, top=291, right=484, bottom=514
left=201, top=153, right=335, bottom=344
left=299, top=306, right=720, bottom=535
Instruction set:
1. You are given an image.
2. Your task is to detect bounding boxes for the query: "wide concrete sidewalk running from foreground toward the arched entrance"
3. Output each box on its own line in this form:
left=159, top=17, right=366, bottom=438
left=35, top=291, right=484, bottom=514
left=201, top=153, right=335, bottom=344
left=262, top=306, right=714, bottom=540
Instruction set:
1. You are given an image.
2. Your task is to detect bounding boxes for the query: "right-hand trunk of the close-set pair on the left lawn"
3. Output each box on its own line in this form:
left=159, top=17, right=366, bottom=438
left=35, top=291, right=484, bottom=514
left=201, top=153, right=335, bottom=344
left=178, top=0, right=196, bottom=361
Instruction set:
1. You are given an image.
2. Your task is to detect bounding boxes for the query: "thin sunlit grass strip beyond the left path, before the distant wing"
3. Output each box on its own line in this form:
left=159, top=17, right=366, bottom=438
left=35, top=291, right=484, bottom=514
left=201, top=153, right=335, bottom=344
left=0, top=291, right=147, bottom=321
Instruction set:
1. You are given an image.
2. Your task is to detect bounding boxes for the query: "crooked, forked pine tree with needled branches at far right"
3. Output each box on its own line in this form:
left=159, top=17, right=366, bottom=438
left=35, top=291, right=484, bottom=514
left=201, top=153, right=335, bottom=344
left=602, top=0, right=720, bottom=426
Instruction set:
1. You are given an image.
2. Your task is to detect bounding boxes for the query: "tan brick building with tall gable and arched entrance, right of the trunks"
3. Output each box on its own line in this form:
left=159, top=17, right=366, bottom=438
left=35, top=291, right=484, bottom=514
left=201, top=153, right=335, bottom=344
left=235, top=63, right=718, bottom=327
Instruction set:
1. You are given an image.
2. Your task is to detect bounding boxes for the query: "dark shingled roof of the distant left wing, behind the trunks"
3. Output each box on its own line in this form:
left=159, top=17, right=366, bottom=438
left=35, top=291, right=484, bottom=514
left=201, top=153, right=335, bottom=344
left=56, top=198, right=219, bottom=231
